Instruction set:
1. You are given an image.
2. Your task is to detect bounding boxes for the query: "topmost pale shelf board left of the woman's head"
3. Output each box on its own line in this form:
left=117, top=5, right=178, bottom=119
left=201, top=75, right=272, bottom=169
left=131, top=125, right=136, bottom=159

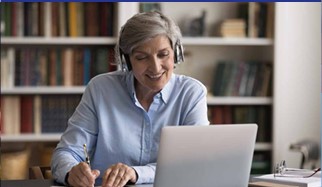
left=1, top=37, right=117, bottom=45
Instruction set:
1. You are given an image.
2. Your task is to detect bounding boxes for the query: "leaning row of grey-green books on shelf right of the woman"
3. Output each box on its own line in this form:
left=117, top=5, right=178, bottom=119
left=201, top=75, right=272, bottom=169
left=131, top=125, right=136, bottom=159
left=211, top=61, right=273, bottom=97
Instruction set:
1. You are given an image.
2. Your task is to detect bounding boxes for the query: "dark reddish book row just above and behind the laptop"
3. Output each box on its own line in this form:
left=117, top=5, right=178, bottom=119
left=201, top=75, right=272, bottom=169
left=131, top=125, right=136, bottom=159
left=208, top=105, right=272, bottom=142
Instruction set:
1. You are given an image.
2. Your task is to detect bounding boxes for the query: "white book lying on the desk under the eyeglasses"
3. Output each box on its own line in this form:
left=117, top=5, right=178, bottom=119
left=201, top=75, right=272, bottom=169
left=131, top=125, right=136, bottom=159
left=254, top=169, right=321, bottom=187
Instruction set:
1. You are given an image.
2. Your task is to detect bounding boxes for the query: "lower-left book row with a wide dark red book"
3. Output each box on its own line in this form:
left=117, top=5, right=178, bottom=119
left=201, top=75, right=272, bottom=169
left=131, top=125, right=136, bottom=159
left=1, top=95, right=81, bottom=134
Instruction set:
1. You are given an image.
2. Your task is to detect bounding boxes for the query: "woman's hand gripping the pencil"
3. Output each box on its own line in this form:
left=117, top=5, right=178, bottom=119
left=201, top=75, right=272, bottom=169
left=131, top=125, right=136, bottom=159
left=67, top=162, right=100, bottom=187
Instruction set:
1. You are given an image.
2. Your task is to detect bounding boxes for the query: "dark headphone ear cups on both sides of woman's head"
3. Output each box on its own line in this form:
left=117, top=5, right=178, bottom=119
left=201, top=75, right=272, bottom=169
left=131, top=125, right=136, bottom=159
left=119, top=40, right=184, bottom=71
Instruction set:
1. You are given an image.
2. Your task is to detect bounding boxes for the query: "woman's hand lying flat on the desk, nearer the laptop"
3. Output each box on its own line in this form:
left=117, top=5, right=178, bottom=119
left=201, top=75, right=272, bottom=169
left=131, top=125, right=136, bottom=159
left=102, top=163, right=137, bottom=187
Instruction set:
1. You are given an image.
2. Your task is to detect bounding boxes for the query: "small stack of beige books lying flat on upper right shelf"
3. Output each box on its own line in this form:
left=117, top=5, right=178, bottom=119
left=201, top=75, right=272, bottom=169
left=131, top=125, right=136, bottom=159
left=220, top=19, right=246, bottom=37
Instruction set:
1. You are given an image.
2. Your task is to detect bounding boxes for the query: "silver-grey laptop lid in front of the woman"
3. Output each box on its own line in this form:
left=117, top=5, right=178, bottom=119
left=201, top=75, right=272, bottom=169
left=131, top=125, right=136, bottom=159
left=154, top=124, right=257, bottom=187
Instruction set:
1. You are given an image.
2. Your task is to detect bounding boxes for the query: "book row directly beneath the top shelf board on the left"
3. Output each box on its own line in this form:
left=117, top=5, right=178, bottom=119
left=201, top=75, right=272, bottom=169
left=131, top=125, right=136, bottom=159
left=1, top=47, right=117, bottom=88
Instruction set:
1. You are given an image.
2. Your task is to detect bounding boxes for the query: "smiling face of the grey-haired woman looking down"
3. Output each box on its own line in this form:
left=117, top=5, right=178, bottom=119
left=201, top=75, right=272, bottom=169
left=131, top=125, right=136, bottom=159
left=130, top=35, right=174, bottom=93
